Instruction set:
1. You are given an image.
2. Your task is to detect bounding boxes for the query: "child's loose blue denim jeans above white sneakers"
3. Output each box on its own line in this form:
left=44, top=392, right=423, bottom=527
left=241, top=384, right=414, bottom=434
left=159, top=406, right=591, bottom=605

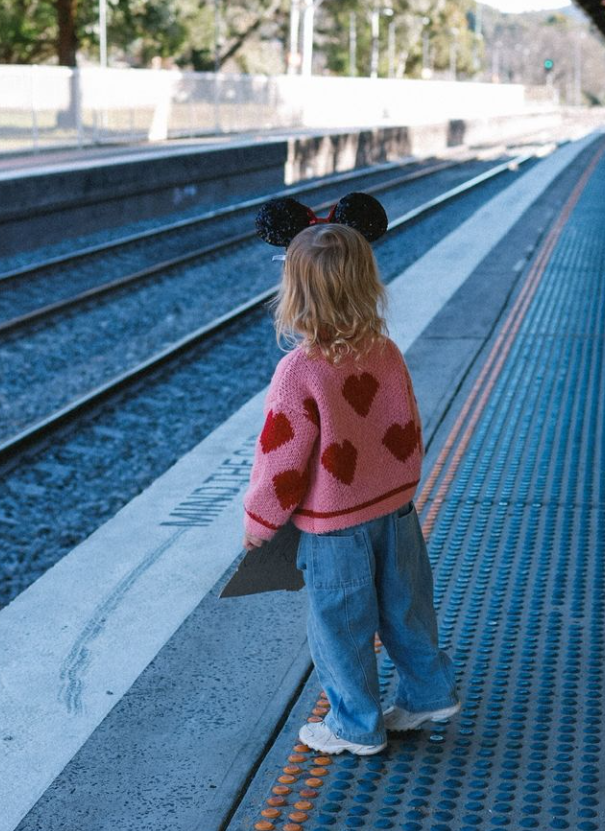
left=297, top=502, right=458, bottom=744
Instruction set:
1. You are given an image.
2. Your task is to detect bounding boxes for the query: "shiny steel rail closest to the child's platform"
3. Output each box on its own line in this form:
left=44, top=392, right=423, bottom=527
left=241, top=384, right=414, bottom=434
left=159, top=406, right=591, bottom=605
left=0, top=153, right=534, bottom=467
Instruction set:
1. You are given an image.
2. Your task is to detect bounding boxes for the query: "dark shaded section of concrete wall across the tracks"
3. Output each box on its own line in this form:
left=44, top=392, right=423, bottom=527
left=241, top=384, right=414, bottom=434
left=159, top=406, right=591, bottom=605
left=0, top=141, right=287, bottom=255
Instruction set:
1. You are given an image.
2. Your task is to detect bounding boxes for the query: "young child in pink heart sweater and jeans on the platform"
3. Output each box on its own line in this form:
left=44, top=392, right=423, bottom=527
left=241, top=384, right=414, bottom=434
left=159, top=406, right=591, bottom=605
left=244, top=216, right=460, bottom=755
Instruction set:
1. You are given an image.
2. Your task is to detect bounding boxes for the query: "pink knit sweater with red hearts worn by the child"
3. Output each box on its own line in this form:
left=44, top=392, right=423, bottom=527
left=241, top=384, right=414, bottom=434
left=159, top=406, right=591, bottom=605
left=244, top=338, right=424, bottom=540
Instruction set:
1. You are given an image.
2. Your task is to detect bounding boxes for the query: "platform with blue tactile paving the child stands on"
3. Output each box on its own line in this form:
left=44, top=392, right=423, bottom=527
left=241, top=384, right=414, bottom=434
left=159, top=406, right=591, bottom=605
left=0, top=132, right=605, bottom=831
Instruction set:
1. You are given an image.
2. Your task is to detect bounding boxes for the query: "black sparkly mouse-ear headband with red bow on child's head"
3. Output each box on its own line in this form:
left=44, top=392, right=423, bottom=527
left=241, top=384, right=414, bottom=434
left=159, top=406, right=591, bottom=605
left=256, top=193, right=389, bottom=247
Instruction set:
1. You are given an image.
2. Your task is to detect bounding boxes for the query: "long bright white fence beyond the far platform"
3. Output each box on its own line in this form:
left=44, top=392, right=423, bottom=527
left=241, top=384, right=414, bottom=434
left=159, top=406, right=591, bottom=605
left=0, top=65, right=556, bottom=152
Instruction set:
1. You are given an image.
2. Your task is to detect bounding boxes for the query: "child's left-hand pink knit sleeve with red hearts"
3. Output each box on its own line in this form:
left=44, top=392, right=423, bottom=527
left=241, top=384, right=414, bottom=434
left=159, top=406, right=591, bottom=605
left=244, top=374, right=319, bottom=540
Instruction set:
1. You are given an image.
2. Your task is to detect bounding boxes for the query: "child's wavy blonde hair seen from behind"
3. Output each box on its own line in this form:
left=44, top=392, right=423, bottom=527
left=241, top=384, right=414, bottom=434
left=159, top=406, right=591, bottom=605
left=272, top=223, right=388, bottom=364
